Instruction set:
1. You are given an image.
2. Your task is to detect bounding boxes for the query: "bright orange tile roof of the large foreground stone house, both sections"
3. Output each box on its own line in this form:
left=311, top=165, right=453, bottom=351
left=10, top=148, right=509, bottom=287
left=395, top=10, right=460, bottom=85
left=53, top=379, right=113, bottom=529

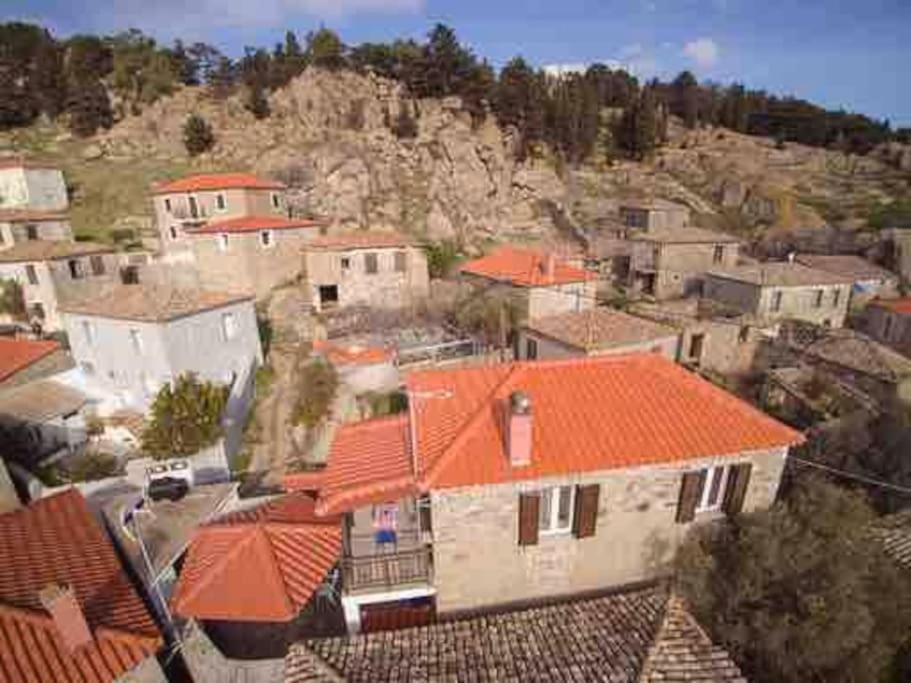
left=296, top=354, right=803, bottom=512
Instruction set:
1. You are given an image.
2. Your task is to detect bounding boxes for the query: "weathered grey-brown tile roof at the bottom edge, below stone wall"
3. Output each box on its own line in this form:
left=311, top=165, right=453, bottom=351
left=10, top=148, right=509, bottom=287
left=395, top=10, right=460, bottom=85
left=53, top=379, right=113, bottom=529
left=285, top=588, right=745, bottom=683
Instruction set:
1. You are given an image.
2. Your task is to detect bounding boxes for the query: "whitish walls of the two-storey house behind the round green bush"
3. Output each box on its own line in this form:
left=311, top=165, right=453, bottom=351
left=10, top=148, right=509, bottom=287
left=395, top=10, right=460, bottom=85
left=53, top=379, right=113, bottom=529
left=65, top=301, right=262, bottom=410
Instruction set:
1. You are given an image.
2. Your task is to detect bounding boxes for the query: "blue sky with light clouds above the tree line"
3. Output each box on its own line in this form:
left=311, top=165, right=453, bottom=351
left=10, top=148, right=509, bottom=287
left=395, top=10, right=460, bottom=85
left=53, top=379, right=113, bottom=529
left=7, top=0, right=911, bottom=125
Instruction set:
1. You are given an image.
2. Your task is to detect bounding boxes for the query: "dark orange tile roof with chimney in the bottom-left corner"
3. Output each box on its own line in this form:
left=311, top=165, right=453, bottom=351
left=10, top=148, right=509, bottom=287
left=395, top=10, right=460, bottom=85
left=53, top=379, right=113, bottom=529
left=0, top=489, right=162, bottom=681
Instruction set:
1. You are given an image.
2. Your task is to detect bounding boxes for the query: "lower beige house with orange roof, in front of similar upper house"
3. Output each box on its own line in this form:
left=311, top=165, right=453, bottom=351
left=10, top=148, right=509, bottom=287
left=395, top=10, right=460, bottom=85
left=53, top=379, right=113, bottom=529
left=183, top=215, right=323, bottom=299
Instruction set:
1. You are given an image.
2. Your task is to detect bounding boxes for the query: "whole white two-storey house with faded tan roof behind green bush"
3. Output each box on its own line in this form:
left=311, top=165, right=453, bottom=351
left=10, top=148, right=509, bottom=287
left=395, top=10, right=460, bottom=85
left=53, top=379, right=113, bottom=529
left=62, top=285, right=263, bottom=412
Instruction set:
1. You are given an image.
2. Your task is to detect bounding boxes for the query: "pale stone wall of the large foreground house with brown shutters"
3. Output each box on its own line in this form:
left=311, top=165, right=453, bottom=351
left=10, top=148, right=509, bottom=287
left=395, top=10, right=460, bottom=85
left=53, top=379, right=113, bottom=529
left=431, top=449, right=786, bottom=612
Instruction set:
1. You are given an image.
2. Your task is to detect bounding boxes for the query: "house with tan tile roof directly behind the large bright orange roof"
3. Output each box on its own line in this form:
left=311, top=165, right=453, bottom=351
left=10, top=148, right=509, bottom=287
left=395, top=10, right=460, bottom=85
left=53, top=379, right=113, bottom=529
left=515, top=306, right=680, bottom=361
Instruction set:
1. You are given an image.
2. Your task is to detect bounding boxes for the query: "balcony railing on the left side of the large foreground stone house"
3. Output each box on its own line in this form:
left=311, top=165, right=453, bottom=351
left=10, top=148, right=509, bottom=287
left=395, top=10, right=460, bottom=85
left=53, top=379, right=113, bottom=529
left=342, top=546, right=433, bottom=593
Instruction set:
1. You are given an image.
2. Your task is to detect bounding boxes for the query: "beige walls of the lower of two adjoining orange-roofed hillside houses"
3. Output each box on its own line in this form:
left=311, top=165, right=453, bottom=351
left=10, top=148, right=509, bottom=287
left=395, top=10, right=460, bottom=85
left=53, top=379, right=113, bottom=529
left=189, top=228, right=319, bottom=298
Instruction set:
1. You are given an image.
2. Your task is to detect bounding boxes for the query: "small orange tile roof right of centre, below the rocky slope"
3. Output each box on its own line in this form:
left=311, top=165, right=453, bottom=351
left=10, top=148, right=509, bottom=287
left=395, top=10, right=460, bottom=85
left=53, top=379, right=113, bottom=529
left=461, top=246, right=594, bottom=287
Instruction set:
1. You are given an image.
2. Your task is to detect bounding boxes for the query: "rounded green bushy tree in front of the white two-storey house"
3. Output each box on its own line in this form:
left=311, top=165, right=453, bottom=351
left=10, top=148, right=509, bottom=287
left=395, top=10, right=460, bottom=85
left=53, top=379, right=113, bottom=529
left=142, top=373, right=228, bottom=460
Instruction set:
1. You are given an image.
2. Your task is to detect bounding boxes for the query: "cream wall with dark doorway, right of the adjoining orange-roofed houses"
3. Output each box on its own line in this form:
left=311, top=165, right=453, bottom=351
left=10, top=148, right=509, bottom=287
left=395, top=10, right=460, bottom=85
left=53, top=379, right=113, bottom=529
left=304, top=247, right=430, bottom=309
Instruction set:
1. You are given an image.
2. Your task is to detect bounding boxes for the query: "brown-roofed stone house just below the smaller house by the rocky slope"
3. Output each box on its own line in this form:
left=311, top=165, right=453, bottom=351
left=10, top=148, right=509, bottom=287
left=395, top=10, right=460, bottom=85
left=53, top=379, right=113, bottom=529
left=627, top=228, right=740, bottom=300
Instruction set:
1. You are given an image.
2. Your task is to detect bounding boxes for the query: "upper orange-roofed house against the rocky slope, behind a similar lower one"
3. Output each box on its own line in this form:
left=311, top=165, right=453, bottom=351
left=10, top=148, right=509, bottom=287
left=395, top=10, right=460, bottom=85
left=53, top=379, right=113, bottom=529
left=152, top=173, right=288, bottom=256
